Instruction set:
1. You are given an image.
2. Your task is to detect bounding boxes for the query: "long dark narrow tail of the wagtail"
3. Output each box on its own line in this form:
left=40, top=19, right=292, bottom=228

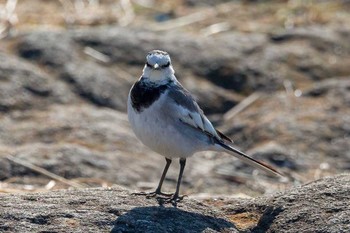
left=217, top=141, right=284, bottom=176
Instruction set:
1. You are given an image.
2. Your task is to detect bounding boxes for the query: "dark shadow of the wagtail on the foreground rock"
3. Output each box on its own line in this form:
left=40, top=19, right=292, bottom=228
left=111, top=206, right=236, bottom=233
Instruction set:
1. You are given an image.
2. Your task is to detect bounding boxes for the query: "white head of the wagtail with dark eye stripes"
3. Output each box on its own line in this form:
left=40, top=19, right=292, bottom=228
left=143, top=50, right=175, bottom=82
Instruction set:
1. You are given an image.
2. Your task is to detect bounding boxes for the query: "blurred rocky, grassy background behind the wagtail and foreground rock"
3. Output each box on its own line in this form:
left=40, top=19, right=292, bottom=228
left=0, top=0, right=350, bottom=197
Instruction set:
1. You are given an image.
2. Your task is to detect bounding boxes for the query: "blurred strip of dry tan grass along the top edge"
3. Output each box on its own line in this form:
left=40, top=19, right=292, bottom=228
left=0, top=0, right=350, bottom=36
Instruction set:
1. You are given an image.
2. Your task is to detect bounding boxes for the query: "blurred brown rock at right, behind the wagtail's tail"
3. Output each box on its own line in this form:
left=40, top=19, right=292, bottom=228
left=221, top=78, right=350, bottom=177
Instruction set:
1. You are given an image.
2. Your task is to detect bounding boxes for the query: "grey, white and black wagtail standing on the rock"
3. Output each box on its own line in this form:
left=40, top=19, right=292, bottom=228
left=128, top=50, right=280, bottom=202
